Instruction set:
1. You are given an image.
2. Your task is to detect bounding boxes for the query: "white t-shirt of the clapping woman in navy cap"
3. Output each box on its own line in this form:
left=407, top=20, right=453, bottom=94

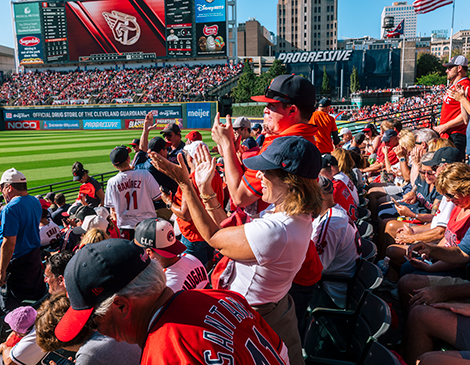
left=228, top=205, right=312, bottom=306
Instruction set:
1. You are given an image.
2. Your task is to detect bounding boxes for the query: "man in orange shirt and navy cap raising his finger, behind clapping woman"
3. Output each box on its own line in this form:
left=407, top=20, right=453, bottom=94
left=212, top=75, right=317, bottom=214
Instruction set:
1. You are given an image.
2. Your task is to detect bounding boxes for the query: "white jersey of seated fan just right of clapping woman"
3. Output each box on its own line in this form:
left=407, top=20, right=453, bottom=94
left=312, top=204, right=361, bottom=308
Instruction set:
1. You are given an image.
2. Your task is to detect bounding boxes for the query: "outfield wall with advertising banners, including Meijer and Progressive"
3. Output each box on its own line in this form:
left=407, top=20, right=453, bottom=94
left=0, top=101, right=218, bottom=130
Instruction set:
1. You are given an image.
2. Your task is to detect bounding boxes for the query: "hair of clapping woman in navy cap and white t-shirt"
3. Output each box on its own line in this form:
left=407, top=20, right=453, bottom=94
left=273, top=169, right=323, bottom=218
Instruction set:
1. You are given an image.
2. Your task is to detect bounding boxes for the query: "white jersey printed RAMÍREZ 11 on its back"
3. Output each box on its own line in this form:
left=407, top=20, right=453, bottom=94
left=104, top=170, right=161, bottom=229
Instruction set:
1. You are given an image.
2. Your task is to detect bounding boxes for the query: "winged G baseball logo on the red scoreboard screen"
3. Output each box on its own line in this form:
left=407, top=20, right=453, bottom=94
left=102, top=10, right=140, bottom=46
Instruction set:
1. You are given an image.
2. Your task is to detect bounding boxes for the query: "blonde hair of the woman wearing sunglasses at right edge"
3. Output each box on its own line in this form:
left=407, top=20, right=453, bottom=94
left=436, top=162, right=470, bottom=196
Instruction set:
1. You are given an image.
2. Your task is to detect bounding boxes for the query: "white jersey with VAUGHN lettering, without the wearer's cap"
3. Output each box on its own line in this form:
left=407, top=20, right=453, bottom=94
left=163, top=253, right=209, bottom=293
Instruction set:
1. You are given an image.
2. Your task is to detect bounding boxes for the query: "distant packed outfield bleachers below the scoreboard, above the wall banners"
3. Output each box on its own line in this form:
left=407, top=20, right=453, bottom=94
left=0, top=64, right=243, bottom=106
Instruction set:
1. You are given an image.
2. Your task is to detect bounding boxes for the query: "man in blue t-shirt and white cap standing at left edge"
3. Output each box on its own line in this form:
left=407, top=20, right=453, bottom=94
left=0, top=168, right=46, bottom=313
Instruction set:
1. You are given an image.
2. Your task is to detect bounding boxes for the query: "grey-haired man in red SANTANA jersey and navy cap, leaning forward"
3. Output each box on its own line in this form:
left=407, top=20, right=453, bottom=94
left=55, top=239, right=287, bottom=364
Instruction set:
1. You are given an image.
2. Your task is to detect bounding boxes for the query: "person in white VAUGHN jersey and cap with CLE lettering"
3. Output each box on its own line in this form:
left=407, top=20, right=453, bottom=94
left=134, top=218, right=209, bottom=293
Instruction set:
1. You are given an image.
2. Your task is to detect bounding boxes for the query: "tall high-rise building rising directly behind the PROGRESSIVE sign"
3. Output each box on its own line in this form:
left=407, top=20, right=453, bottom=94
left=277, top=0, right=338, bottom=52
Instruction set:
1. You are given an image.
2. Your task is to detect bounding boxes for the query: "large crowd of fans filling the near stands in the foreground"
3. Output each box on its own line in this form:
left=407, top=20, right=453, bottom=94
left=0, top=56, right=470, bottom=365
